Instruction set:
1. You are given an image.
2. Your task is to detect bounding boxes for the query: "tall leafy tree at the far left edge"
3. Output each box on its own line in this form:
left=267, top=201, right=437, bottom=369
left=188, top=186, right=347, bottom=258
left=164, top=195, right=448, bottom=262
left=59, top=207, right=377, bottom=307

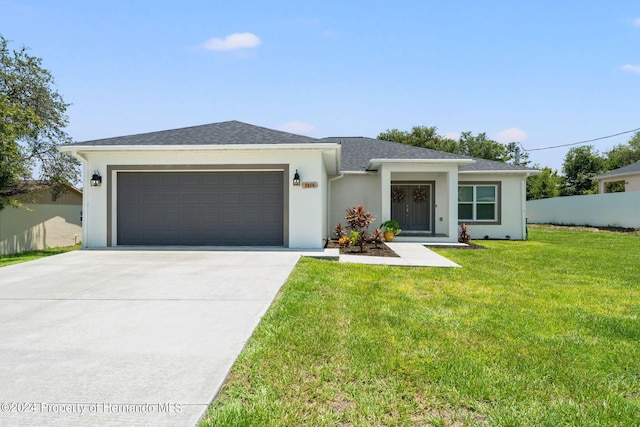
left=0, top=35, right=80, bottom=209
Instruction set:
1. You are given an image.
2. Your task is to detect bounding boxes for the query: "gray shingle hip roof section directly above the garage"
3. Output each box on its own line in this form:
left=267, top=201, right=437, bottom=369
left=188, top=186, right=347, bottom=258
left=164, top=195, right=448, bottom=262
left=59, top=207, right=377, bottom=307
left=70, top=120, right=322, bottom=146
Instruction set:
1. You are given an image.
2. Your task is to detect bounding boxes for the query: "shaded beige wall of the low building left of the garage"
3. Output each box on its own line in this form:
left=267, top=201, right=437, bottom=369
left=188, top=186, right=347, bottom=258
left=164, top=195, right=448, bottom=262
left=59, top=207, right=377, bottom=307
left=0, top=204, right=82, bottom=254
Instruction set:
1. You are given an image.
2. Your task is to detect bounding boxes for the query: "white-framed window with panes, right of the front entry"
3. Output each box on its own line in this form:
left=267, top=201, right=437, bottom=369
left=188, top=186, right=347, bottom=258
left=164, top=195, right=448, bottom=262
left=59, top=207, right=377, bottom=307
left=458, top=184, right=499, bottom=222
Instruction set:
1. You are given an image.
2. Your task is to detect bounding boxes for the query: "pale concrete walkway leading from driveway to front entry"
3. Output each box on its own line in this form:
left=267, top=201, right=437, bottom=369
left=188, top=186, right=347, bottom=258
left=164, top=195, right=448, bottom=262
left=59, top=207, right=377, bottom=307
left=340, top=242, right=460, bottom=267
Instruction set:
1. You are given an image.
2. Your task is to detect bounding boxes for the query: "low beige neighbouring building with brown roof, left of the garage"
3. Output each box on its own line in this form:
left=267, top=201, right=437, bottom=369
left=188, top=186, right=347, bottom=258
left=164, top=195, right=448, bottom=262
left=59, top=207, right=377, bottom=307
left=0, top=181, right=82, bottom=254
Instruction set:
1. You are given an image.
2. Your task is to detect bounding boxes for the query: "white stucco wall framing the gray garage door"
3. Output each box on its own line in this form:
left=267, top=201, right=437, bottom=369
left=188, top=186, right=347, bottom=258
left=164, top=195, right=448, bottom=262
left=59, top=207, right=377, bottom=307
left=80, top=148, right=327, bottom=248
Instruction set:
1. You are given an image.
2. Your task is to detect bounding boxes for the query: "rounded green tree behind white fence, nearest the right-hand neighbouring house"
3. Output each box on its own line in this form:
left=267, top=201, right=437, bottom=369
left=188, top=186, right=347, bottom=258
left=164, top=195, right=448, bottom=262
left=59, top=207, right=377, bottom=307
left=561, top=145, right=605, bottom=196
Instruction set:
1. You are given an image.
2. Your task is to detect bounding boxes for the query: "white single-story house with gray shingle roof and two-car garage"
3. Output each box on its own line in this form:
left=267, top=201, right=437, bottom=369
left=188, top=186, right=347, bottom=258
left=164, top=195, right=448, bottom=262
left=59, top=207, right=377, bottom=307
left=60, top=121, right=537, bottom=248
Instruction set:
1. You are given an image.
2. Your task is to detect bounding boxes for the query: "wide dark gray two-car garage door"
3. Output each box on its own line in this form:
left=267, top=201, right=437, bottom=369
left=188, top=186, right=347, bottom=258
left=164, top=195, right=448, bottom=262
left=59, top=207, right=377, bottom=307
left=117, top=171, right=284, bottom=246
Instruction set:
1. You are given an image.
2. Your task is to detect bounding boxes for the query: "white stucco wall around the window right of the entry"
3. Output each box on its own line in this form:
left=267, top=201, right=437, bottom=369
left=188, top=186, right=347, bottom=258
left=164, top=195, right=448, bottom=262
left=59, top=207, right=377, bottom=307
left=455, top=173, right=526, bottom=240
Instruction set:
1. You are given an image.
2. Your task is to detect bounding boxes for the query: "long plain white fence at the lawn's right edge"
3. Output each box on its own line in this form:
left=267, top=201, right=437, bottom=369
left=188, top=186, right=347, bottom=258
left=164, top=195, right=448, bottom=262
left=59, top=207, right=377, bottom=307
left=527, top=191, right=640, bottom=228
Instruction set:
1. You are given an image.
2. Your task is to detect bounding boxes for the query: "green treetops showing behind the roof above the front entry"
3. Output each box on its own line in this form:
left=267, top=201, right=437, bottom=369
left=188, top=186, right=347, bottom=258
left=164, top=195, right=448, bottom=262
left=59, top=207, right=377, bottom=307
left=377, top=126, right=529, bottom=166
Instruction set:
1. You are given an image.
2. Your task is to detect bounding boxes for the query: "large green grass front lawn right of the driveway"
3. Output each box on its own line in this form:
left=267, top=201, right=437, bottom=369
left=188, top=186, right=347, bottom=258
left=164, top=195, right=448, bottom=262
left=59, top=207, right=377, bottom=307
left=201, top=226, right=640, bottom=427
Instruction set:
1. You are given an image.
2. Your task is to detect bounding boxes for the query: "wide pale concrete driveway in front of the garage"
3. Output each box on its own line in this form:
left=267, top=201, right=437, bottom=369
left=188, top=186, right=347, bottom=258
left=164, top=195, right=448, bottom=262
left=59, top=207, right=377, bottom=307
left=0, top=250, right=299, bottom=426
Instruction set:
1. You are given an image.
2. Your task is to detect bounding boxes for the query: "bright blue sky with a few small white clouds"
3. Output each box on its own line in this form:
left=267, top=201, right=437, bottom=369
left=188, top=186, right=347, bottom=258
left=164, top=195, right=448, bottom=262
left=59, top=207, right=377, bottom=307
left=0, top=0, right=640, bottom=170
